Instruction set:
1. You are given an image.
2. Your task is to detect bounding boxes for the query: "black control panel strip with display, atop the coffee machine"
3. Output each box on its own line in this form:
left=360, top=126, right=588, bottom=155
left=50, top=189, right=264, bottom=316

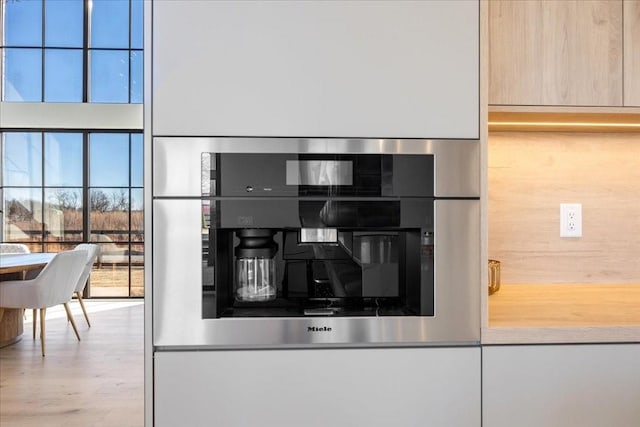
left=203, top=153, right=434, bottom=197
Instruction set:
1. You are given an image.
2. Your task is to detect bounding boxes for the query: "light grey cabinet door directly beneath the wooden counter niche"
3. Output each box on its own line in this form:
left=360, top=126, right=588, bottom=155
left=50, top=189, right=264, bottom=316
left=482, top=344, right=640, bottom=427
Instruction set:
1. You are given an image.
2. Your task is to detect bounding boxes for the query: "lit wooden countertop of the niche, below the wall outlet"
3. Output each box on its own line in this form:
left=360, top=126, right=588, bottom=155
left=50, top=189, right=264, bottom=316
left=482, top=283, right=640, bottom=344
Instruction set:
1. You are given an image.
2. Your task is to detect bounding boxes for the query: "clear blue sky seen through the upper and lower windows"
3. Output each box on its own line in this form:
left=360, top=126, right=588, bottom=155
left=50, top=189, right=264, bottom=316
left=1, top=0, right=143, bottom=211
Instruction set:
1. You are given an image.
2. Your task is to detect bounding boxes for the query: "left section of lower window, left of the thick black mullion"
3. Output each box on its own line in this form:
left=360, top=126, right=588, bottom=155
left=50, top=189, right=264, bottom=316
left=2, top=132, right=84, bottom=247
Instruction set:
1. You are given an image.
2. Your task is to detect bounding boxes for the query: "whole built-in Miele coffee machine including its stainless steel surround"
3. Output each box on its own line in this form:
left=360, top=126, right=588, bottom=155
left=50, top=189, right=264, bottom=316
left=150, top=137, right=478, bottom=350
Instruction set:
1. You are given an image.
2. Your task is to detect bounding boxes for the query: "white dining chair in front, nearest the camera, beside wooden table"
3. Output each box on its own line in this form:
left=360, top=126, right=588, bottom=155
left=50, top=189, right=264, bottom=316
left=0, top=250, right=87, bottom=356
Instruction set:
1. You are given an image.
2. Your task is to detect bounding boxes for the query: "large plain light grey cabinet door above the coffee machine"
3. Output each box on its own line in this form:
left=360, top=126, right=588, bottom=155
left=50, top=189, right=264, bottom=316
left=152, top=0, right=479, bottom=139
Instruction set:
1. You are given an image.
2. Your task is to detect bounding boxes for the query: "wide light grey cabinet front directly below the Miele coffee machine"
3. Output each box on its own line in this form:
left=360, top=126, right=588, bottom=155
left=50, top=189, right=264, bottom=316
left=154, top=347, right=480, bottom=427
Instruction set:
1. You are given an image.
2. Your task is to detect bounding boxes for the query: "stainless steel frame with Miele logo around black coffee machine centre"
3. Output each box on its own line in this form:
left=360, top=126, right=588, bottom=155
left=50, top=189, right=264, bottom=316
left=151, top=137, right=481, bottom=350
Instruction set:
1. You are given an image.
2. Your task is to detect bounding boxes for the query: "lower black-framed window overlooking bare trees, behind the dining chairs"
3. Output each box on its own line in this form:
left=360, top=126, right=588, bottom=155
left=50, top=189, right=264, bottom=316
left=0, top=132, right=144, bottom=296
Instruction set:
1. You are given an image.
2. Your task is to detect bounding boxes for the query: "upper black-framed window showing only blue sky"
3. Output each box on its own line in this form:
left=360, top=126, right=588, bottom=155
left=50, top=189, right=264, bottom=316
left=0, top=0, right=143, bottom=103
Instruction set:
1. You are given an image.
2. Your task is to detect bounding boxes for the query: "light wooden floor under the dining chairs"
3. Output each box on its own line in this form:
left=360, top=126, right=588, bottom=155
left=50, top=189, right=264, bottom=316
left=0, top=300, right=144, bottom=427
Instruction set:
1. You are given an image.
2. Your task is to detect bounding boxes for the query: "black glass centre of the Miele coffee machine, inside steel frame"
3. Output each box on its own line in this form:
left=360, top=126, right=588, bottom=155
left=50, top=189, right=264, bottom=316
left=202, top=153, right=434, bottom=318
